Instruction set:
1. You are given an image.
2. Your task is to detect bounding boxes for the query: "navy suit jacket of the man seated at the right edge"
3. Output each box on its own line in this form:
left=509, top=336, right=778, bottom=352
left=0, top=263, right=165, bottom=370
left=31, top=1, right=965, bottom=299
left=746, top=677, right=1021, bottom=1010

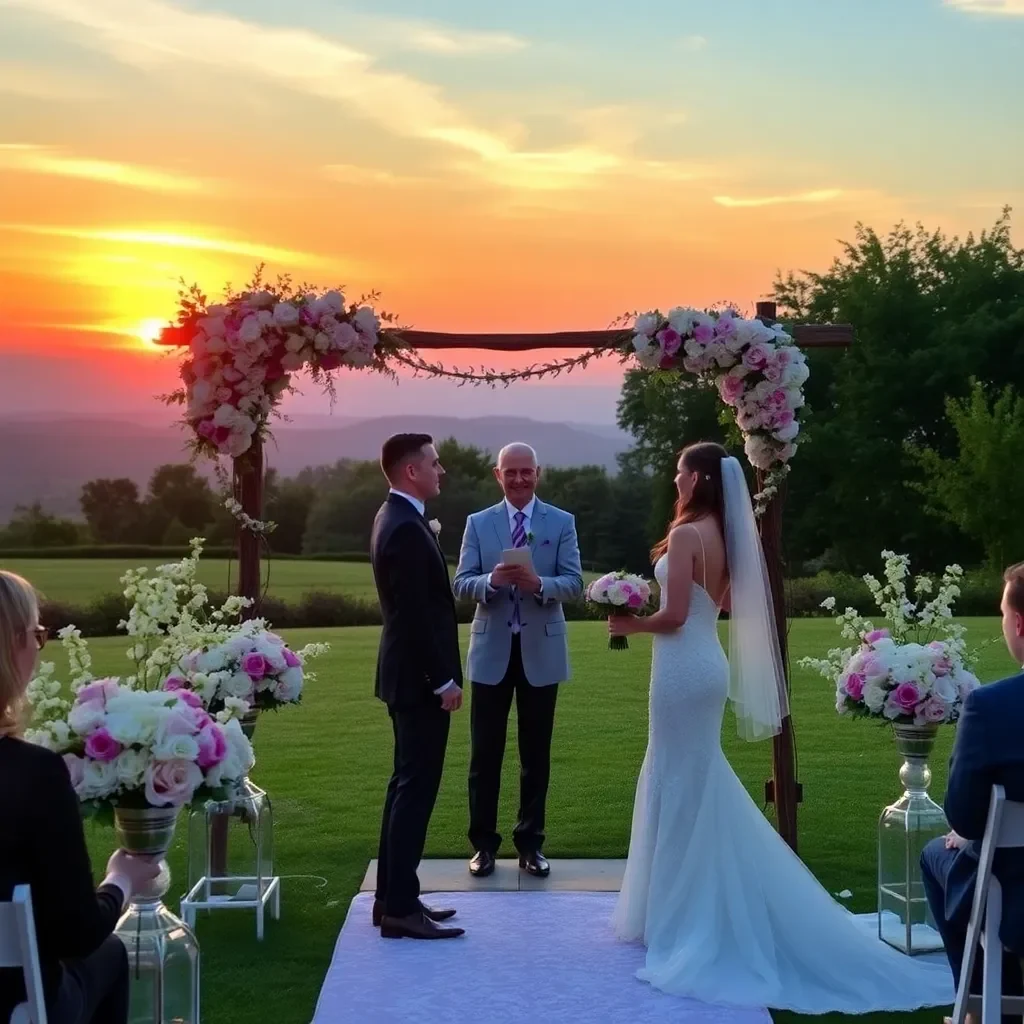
left=945, top=674, right=1024, bottom=952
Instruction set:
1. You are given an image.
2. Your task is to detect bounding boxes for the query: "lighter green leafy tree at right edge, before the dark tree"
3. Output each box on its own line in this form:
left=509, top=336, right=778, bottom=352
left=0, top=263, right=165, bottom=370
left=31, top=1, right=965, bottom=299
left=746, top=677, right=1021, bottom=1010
left=907, top=381, right=1024, bottom=568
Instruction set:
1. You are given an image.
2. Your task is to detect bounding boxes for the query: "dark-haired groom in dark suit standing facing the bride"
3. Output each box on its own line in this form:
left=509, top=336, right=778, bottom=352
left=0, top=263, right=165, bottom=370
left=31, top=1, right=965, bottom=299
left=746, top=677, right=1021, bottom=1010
left=370, top=434, right=463, bottom=939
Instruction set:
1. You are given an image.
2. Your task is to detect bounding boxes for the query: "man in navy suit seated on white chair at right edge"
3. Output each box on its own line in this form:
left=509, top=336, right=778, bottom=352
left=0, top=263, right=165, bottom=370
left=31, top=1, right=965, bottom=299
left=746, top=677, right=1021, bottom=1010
left=921, top=562, right=1024, bottom=1022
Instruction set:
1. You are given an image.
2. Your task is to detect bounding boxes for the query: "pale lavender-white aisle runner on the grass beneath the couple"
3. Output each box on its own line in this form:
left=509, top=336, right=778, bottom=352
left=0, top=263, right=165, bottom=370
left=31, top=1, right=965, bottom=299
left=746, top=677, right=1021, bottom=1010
left=313, top=892, right=771, bottom=1024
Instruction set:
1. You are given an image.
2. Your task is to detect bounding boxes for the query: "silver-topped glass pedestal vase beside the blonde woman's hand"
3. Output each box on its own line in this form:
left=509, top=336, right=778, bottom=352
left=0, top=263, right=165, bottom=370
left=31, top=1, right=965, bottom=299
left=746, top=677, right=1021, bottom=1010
left=114, top=807, right=200, bottom=1024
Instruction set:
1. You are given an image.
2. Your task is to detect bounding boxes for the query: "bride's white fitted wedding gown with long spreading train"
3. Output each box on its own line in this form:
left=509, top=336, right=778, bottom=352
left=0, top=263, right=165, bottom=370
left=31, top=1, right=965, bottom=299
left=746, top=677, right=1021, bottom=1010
left=613, top=556, right=953, bottom=1014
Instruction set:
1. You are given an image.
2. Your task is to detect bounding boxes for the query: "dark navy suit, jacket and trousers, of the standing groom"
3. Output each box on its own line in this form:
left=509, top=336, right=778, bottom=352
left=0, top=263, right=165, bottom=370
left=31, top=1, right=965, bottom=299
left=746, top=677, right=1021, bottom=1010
left=370, top=494, right=462, bottom=918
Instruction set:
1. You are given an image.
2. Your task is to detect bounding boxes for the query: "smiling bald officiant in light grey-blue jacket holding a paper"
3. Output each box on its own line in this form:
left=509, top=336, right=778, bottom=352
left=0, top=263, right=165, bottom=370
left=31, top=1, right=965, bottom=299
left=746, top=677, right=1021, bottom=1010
left=455, top=443, right=583, bottom=878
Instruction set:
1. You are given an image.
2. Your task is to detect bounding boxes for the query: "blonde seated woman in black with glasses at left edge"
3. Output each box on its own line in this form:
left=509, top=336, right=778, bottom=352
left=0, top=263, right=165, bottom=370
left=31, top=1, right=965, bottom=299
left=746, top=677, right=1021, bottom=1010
left=0, top=570, right=159, bottom=1024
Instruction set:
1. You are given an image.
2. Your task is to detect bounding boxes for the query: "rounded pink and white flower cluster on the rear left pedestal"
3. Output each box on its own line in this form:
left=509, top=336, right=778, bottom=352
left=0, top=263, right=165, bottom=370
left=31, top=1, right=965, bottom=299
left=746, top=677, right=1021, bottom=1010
left=162, top=620, right=322, bottom=712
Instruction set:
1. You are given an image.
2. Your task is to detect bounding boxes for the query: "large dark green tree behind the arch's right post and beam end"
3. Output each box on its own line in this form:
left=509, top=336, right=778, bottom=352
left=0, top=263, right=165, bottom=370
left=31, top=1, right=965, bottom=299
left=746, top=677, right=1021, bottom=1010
left=775, top=211, right=1024, bottom=572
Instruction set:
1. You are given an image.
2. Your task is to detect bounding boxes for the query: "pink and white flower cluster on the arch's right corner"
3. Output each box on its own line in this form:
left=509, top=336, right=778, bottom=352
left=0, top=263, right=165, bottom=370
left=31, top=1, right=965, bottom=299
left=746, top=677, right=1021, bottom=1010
left=631, top=306, right=810, bottom=514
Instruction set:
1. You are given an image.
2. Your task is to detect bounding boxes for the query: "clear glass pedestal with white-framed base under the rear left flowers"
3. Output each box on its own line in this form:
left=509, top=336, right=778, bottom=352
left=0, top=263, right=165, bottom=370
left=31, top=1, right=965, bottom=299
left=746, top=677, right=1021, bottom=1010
left=181, top=712, right=281, bottom=939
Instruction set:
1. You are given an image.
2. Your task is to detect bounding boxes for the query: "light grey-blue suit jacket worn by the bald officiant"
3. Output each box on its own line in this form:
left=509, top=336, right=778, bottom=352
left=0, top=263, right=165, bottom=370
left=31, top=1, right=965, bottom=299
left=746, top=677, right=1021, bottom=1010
left=454, top=500, right=583, bottom=686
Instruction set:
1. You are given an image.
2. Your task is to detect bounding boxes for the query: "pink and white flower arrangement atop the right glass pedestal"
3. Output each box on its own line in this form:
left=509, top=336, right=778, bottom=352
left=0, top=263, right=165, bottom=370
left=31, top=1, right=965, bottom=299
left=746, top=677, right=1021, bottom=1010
left=800, top=551, right=979, bottom=725
